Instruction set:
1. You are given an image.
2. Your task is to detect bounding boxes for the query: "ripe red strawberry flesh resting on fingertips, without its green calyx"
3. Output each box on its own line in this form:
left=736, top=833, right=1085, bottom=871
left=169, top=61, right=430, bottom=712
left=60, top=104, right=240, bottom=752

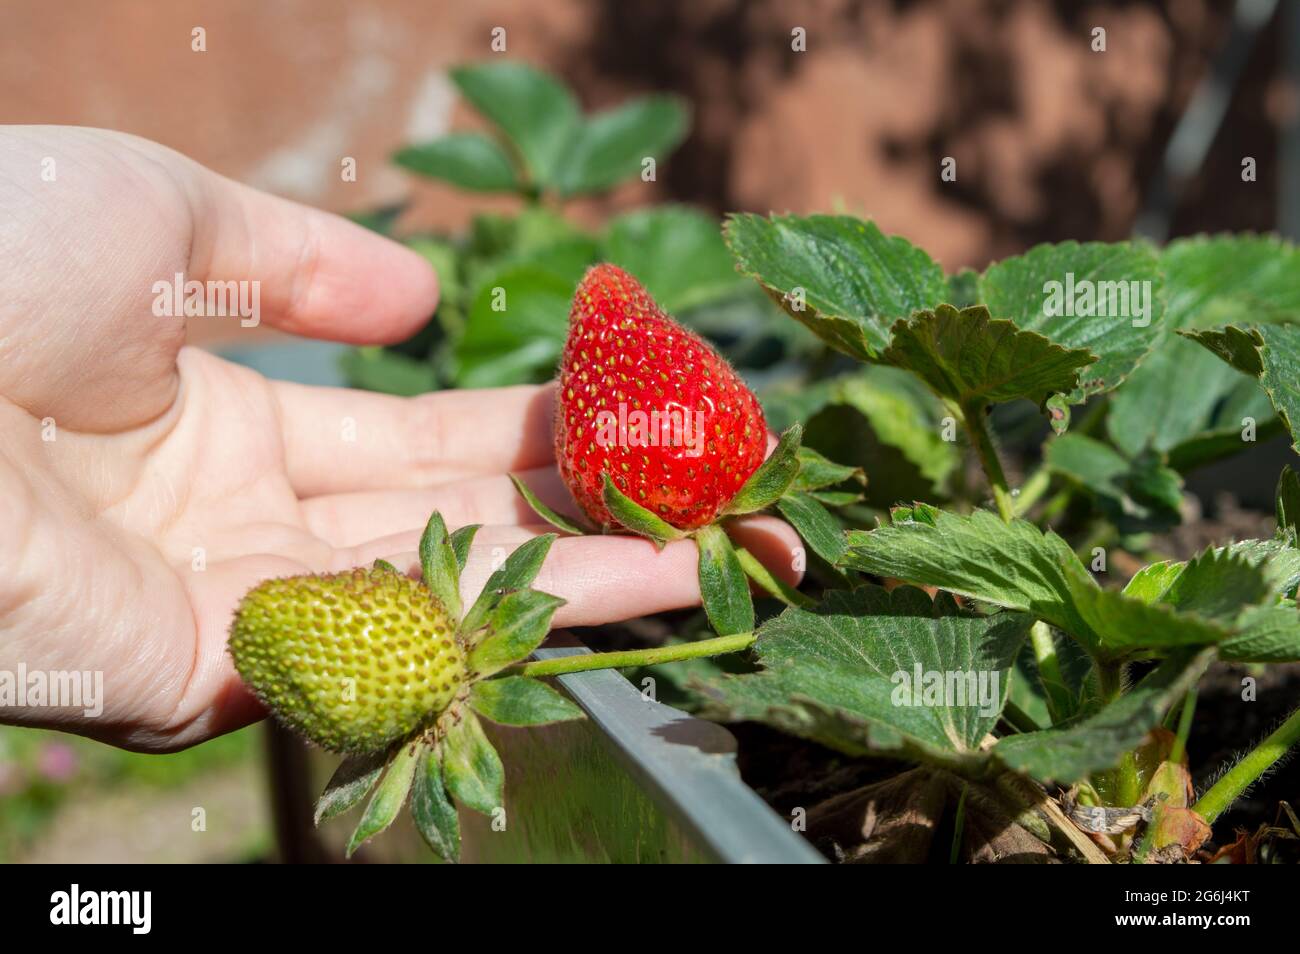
left=555, top=264, right=767, bottom=530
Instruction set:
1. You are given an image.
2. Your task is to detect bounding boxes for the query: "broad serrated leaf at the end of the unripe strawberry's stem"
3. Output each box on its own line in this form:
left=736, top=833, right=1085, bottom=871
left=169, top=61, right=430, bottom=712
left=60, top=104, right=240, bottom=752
left=703, top=585, right=1031, bottom=771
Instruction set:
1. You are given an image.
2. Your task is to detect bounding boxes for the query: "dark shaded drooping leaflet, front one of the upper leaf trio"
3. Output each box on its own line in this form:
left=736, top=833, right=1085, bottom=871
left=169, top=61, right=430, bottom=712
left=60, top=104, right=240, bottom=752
left=881, top=304, right=1096, bottom=406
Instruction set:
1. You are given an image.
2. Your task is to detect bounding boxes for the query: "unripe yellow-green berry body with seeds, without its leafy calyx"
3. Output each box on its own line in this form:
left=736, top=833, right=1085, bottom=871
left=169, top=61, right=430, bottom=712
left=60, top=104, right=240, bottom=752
left=230, top=569, right=467, bottom=753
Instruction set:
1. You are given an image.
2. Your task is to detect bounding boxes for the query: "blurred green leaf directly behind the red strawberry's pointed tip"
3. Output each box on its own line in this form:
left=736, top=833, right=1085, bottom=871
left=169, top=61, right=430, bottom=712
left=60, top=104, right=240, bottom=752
left=605, top=205, right=744, bottom=315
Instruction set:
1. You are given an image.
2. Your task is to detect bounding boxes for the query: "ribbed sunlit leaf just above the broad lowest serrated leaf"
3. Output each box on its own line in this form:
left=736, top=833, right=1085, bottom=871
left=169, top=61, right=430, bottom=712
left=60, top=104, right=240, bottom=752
left=840, top=508, right=1097, bottom=657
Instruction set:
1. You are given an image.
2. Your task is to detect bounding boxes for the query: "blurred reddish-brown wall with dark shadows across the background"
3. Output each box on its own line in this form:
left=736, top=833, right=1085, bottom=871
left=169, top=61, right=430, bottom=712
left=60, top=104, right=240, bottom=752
left=0, top=0, right=1296, bottom=343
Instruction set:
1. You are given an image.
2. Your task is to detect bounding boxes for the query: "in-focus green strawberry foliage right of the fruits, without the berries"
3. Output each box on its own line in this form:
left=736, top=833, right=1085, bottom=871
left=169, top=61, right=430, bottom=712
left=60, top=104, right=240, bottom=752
left=699, top=216, right=1300, bottom=860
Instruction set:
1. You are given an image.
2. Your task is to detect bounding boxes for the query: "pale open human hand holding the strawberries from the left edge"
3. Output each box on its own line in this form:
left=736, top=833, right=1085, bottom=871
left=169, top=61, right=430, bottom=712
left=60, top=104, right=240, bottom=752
left=0, top=126, right=798, bottom=751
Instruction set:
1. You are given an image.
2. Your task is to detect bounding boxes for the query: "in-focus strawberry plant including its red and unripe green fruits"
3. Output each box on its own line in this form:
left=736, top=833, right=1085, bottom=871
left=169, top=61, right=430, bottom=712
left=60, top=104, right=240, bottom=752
left=231, top=216, right=1300, bottom=862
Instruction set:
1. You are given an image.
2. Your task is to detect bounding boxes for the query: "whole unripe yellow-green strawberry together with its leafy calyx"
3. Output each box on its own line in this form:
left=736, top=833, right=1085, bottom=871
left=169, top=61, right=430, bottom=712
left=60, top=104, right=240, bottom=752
left=230, top=513, right=582, bottom=860
